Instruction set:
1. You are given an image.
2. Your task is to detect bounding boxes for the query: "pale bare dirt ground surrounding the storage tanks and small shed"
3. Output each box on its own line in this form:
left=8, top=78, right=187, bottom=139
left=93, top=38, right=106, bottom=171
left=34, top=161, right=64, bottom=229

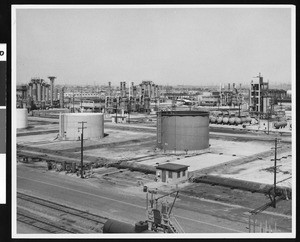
left=17, top=118, right=292, bottom=222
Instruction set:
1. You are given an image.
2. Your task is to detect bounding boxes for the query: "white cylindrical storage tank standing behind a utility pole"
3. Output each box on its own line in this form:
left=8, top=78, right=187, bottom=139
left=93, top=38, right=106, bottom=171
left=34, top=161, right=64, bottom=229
left=59, top=113, right=104, bottom=140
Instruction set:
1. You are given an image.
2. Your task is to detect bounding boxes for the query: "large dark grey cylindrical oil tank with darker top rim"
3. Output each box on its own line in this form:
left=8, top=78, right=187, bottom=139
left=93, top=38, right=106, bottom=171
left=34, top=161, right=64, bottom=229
left=157, top=111, right=209, bottom=151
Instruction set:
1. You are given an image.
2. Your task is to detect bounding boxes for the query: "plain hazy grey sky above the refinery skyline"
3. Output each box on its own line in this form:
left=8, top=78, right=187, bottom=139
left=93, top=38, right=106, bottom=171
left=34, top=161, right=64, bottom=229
left=16, top=8, right=291, bottom=85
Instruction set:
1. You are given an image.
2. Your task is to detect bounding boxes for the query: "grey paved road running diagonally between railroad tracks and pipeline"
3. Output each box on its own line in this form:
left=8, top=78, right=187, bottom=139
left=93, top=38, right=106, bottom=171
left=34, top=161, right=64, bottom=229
left=17, top=165, right=292, bottom=233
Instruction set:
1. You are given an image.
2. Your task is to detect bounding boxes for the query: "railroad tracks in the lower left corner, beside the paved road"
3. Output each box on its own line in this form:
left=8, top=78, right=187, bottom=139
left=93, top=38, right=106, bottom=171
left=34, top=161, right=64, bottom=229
left=17, top=192, right=108, bottom=233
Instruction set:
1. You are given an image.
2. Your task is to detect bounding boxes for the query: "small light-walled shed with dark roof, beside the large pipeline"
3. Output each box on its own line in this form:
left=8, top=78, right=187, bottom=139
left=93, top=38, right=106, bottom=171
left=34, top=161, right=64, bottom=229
left=156, top=163, right=189, bottom=183
